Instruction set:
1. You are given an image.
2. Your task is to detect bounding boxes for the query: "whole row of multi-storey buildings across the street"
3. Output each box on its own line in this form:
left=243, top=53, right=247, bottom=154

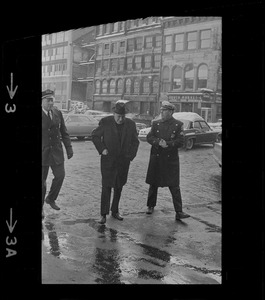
left=42, top=16, right=222, bottom=122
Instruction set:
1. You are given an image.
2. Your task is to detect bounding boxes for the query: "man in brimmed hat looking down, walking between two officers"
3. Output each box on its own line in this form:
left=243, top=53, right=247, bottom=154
left=92, top=100, right=139, bottom=224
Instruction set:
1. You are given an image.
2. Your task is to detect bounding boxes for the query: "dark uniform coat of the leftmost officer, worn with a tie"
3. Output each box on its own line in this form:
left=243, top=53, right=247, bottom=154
left=42, top=108, right=73, bottom=166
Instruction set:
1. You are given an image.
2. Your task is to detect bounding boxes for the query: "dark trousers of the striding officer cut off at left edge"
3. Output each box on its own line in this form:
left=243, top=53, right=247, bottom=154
left=42, top=163, right=65, bottom=205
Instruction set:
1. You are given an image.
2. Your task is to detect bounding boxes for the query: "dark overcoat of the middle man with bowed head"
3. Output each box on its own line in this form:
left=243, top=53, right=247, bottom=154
left=92, top=116, right=139, bottom=187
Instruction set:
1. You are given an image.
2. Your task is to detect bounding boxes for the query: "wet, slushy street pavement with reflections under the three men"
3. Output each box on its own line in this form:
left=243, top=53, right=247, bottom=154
left=42, top=140, right=221, bottom=284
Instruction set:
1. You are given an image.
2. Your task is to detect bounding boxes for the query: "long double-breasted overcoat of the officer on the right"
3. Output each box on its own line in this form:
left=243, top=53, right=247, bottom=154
left=146, top=117, right=183, bottom=187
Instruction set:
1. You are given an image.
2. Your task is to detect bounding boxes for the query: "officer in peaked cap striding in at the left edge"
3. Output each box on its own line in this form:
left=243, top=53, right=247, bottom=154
left=42, top=90, right=73, bottom=210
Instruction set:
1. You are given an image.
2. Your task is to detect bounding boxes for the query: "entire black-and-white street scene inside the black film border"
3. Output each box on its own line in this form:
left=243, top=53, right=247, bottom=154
left=42, top=16, right=222, bottom=285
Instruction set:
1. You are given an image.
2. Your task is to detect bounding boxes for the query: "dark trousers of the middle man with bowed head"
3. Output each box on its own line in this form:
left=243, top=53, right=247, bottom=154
left=100, top=186, right=122, bottom=216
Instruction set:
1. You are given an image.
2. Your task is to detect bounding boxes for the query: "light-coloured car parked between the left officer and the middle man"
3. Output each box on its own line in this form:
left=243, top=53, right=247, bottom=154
left=63, top=114, right=98, bottom=140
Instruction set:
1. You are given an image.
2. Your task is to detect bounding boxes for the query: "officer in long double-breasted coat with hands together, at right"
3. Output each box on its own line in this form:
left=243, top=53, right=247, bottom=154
left=146, top=101, right=189, bottom=220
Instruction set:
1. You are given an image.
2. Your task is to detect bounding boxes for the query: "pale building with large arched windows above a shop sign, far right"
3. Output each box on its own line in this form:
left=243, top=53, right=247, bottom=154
left=160, top=17, right=222, bottom=122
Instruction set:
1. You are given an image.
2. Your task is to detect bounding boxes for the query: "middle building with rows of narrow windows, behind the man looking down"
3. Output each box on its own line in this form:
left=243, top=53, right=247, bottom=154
left=93, top=17, right=162, bottom=116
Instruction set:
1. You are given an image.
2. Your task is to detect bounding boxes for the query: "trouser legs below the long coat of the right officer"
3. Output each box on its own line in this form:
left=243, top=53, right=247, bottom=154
left=147, top=185, right=182, bottom=212
